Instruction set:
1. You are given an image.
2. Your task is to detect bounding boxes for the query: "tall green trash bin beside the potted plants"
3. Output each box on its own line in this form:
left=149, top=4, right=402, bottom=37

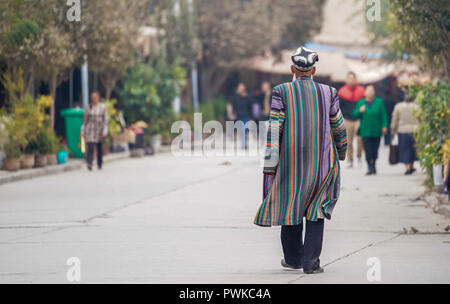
left=61, top=109, right=84, bottom=158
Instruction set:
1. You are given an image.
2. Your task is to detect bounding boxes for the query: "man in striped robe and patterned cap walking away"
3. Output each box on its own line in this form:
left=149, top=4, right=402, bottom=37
left=255, top=47, right=347, bottom=274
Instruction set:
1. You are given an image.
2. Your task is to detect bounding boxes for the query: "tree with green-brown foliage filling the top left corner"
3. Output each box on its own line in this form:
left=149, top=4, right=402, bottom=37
left=0, top=0, right=75, bottom=127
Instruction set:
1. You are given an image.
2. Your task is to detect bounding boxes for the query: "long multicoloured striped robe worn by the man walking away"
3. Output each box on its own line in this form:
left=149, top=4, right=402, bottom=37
left=255, top=77, right=347, bottom=227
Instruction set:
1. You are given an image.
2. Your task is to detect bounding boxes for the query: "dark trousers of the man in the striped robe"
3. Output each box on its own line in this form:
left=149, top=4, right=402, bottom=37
left=281, top=220, right=325, bottom=270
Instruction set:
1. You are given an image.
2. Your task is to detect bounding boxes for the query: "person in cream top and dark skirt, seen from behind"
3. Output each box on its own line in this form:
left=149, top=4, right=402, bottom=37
left=391, top=96, right=419, bottom=175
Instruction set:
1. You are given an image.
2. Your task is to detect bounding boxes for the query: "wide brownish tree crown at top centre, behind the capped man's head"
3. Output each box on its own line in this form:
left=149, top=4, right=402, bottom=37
left=153, top=0, right=324, bottom=100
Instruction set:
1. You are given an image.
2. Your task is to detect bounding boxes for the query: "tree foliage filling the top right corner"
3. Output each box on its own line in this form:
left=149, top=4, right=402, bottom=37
left=369, top=0, right=450, bottom=81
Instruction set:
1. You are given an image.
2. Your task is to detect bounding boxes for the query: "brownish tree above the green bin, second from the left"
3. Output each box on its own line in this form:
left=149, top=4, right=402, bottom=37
left=78, top=0, right=146, bottom=99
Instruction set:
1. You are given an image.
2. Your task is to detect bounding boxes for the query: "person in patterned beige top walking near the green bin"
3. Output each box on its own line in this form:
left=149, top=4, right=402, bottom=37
left=81, top=92, right=108, bottom=171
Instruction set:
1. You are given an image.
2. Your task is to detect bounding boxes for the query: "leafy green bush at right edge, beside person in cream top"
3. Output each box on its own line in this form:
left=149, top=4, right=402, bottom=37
left=410, top=84, right=450, bottom=184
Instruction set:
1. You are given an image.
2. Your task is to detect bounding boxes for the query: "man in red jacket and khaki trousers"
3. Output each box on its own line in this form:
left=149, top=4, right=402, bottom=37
left=338, top=72, right=365, bottom=167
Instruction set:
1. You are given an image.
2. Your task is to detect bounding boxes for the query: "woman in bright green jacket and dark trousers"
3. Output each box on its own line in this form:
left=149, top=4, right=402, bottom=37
left=353, top=85, right=389, bottom=175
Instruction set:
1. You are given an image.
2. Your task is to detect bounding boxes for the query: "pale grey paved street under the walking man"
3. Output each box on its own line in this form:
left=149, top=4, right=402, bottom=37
left=0, top=150, right=450, bottom=284
